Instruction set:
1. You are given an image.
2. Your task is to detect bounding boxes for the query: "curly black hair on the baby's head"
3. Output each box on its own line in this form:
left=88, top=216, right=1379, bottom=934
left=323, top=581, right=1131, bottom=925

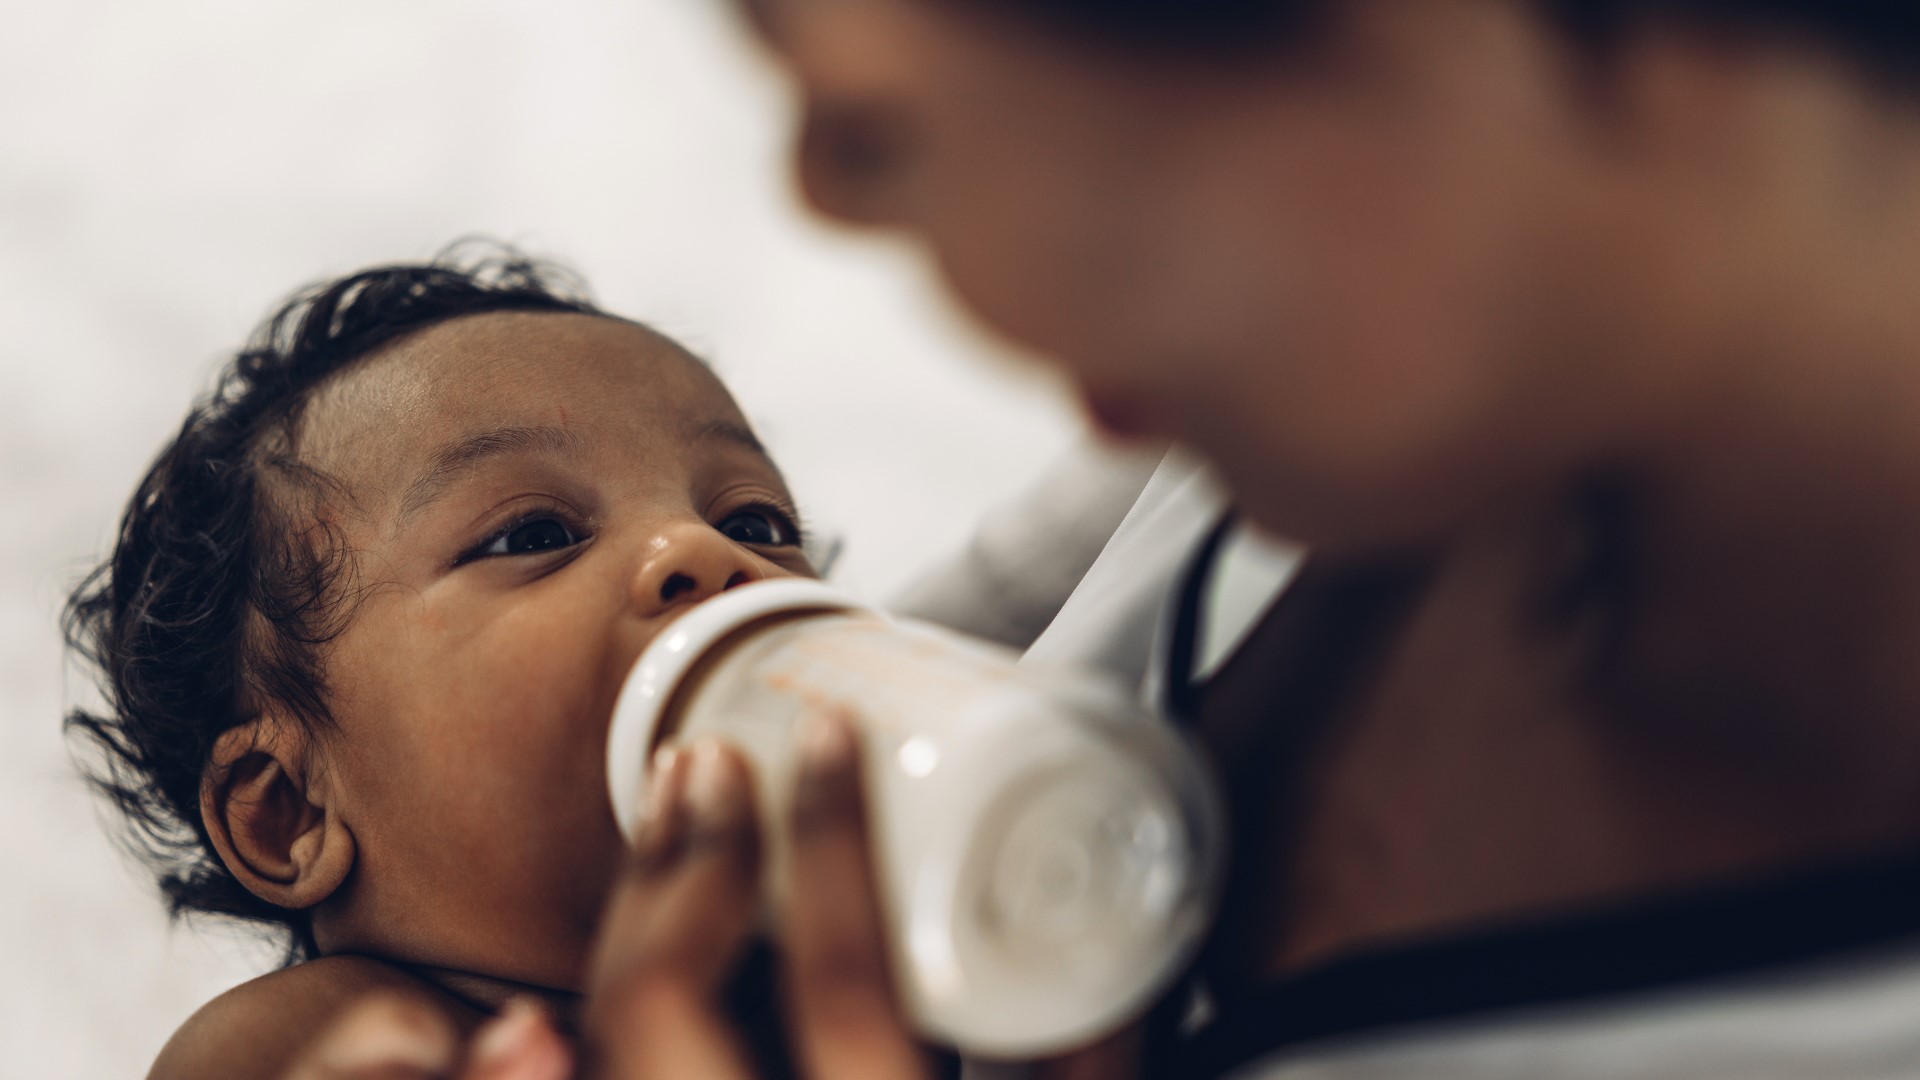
left=63, top=242, right=603, bottom=963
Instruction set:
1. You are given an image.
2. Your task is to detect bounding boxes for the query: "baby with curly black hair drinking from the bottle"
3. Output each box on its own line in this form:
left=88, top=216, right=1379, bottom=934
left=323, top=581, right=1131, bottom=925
left=67, top=254, right=814, bottom=1076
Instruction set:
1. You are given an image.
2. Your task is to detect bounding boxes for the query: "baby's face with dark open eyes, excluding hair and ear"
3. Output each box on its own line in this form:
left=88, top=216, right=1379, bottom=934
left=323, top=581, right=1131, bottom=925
left=289, top=313, right=812, bottom=988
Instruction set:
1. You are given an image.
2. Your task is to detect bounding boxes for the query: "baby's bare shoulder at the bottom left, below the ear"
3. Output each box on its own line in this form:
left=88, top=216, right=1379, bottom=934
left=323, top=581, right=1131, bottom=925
left=148, top=955, right=470, bottom=1080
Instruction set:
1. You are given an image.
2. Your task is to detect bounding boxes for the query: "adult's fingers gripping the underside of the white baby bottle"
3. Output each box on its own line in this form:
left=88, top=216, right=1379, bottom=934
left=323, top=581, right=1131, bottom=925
left=584, top=713, right=925, bottom=1080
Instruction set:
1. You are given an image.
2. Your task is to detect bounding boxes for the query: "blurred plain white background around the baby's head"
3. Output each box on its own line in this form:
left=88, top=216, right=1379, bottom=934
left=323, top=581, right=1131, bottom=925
left=0, top=0, right=1079, bottom=1078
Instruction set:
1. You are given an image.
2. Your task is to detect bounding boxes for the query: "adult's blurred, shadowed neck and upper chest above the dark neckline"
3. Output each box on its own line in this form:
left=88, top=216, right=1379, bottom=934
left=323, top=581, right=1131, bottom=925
left=1265, top=125, right=1920, bottom=974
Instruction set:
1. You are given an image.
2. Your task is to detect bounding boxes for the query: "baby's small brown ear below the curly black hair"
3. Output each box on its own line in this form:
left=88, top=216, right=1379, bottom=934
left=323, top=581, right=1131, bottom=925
left=200, top=715, right=355, bottom=909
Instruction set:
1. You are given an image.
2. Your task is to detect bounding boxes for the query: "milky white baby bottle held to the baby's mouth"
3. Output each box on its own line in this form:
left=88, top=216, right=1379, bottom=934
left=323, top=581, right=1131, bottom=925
left=607, top=578, right=1223, bottom=1057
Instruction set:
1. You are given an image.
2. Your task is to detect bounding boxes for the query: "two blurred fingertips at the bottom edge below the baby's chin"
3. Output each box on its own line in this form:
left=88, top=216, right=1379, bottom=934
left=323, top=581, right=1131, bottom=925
left=284, top=994, right=574, bottom=1080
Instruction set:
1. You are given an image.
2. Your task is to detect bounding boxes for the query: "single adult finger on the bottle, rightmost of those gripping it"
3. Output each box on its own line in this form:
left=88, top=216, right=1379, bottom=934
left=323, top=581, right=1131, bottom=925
left=781, top=713, right=925, bottom=1080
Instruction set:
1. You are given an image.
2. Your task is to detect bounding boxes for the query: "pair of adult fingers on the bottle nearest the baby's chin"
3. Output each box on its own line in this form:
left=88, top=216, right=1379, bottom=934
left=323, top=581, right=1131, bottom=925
left=584, top=740, right=760, bottom=1080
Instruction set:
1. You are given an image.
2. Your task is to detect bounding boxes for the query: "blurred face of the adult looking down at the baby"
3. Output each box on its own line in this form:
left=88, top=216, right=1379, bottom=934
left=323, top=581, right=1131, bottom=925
left=747, top=0, right=1658, bottom=540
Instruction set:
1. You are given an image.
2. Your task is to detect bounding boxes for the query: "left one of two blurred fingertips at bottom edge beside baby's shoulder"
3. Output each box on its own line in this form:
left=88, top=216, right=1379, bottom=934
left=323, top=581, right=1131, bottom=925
left=284, top=994, right=459, bottom=1080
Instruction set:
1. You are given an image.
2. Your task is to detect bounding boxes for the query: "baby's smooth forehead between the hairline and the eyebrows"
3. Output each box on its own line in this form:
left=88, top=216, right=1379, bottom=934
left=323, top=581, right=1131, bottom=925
left=298, top=311, right=745, bottom=496
